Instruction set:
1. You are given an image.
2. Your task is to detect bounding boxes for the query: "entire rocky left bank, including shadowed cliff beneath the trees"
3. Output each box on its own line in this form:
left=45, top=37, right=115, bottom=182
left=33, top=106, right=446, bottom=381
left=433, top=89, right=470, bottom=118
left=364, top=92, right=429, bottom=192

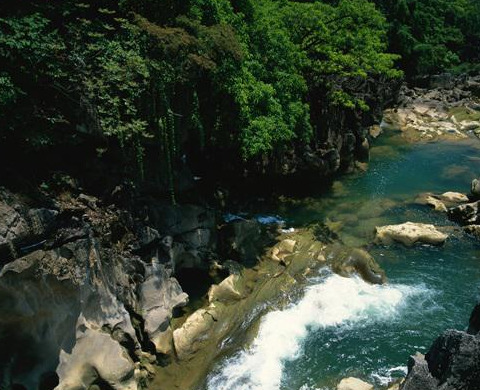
left=0, top=61, right=404, bottom=390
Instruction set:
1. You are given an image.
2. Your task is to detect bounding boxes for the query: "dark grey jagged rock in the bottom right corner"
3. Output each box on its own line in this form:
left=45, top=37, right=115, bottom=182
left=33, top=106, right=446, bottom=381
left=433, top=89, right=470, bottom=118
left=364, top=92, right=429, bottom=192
left=400, top=305, right=480, bottom=390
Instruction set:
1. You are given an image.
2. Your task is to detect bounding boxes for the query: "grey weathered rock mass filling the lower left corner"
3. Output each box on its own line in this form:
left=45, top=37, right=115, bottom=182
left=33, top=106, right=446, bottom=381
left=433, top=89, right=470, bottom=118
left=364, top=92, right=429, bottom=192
left=0, top=189, right=195, bottom=390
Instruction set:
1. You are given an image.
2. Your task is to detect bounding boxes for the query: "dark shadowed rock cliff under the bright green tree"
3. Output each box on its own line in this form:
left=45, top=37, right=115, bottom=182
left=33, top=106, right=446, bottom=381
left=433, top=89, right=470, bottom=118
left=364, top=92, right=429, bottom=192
left=252, top=77, right=401, bottom=179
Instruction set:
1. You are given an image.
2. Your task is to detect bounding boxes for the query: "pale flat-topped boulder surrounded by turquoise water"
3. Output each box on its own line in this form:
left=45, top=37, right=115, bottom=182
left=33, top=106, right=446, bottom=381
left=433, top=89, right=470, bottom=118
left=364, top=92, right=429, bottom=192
left=375, top=222, right=448, bottom=246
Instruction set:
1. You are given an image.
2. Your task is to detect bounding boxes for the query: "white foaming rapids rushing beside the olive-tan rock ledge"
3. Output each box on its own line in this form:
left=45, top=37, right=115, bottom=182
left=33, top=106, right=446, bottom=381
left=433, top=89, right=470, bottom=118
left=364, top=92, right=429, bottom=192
left=208, top=275, right=422, bottom=390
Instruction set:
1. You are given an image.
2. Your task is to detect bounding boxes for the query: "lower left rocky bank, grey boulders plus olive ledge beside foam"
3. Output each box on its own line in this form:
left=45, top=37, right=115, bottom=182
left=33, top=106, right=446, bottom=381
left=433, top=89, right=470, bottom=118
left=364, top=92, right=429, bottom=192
left=0, top=181, right=385, bottom=389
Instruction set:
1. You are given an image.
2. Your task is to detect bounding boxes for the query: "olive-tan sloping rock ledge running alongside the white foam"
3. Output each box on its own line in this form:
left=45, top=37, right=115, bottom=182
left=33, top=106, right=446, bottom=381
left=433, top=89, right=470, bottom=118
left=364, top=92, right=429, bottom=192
left=153, top=229, right=385, bottom=388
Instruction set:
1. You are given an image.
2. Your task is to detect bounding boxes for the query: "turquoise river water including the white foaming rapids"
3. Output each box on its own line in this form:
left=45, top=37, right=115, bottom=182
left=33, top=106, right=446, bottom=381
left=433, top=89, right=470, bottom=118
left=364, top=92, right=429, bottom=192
left=207, top=133, right=480, bottom=390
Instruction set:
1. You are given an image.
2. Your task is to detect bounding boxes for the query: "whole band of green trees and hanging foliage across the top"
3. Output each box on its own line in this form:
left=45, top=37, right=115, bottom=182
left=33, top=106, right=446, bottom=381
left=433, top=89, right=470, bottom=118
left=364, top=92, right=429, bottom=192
left=0, top=0, right=480, bottom=186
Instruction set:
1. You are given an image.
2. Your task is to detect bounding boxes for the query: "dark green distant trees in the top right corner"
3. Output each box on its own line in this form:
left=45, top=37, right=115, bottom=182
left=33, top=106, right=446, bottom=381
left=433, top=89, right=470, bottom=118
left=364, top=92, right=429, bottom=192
left=375, top=0, right=480, bottom=76
